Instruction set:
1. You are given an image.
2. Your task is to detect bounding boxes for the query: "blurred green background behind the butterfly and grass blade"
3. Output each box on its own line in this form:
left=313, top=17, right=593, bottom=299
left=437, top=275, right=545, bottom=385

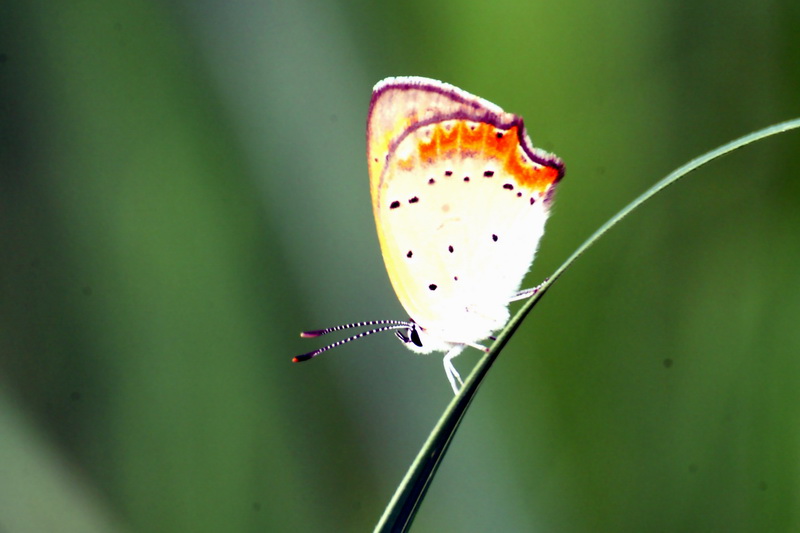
left=0, top=0, right=800, bottom=533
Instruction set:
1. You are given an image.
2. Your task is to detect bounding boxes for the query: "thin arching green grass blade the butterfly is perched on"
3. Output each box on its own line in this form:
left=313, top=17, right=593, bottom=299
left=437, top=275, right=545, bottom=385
left=375, top=118, right=800, bottom=532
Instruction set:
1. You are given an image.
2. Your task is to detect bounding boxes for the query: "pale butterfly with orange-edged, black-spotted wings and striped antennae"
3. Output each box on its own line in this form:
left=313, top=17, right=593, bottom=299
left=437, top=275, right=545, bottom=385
left=293, top=77, right=564, bottom=394
